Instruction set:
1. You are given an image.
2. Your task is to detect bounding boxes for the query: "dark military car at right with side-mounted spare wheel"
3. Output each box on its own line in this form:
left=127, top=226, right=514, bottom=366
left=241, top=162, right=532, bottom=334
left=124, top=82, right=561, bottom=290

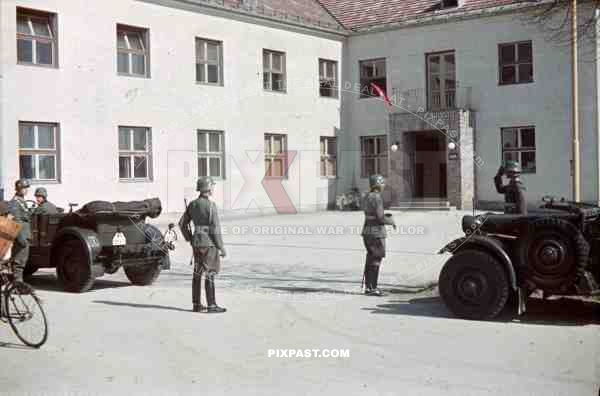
left=439, top=197, right=600, bottom=319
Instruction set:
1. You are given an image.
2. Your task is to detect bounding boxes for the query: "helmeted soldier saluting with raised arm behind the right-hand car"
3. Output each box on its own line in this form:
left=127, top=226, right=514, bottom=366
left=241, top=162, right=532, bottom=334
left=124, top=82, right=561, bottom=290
left=494, top=161, right=527, bottom=215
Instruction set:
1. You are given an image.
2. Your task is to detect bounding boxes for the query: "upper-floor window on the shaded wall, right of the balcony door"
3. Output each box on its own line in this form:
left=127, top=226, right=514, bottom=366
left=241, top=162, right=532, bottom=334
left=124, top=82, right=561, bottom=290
left=498, top=41, right=533, bottom=85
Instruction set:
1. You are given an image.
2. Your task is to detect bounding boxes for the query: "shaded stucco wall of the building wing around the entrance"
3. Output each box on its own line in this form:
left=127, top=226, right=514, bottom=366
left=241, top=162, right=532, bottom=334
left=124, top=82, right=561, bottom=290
left=341, top=7, right=599, bottom=206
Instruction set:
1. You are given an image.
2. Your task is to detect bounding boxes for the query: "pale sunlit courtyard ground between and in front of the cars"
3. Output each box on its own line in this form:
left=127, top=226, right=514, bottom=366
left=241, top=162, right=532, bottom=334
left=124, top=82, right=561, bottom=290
left=0, top=212, right=600, bottom=396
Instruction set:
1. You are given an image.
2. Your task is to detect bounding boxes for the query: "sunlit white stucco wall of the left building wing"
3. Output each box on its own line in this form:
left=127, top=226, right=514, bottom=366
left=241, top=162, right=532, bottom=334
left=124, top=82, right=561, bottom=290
left=0, top=0, right=342, bottom=211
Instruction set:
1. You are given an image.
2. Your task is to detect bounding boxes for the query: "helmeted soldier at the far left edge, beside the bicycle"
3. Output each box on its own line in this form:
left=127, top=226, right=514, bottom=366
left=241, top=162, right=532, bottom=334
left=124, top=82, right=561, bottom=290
left=8, top=179, right=31, bottom=282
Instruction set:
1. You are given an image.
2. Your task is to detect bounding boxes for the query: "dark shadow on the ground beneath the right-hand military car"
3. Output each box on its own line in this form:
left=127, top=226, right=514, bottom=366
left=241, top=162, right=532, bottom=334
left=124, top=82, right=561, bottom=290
left=363, top=297, right=600, bottom=326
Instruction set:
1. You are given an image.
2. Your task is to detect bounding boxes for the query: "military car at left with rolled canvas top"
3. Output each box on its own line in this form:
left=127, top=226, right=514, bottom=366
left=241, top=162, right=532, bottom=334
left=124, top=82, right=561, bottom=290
left=25, top=198, right=177, bottom=293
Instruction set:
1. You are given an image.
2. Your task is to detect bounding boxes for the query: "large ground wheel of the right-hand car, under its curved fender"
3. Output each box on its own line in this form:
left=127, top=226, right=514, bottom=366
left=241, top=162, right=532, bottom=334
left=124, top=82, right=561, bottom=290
left=439, top=249, right=509, bottom=320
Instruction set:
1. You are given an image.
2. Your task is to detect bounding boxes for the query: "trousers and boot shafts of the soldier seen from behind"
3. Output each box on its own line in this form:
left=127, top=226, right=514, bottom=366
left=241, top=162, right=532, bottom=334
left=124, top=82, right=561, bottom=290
left=192, top=246, right=220, bottom=306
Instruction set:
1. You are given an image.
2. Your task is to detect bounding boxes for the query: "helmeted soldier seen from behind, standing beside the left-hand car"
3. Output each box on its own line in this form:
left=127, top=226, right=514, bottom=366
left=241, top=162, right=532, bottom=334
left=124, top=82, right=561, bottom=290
left=179, top=177, right=226, bottom=313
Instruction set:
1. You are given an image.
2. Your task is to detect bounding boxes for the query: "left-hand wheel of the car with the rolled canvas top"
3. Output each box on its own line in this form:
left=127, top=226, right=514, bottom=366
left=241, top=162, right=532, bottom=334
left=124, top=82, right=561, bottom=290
left=56, top=239, right=94, bottom=293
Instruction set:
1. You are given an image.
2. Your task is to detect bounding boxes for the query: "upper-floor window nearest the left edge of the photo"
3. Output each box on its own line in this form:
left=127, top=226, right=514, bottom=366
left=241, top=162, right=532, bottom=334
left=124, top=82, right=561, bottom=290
left=17, top=8, right=57, bottom=66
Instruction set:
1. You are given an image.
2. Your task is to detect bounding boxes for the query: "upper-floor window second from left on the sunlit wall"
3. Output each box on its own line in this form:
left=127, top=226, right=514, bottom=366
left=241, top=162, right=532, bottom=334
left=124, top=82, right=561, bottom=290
left=117, top=25, right=149, bottom=77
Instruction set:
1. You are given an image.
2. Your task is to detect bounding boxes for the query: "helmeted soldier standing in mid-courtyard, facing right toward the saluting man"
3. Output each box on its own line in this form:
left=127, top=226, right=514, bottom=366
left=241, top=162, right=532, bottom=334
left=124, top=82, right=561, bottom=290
left=362, top=175, right=396, bottom=296
